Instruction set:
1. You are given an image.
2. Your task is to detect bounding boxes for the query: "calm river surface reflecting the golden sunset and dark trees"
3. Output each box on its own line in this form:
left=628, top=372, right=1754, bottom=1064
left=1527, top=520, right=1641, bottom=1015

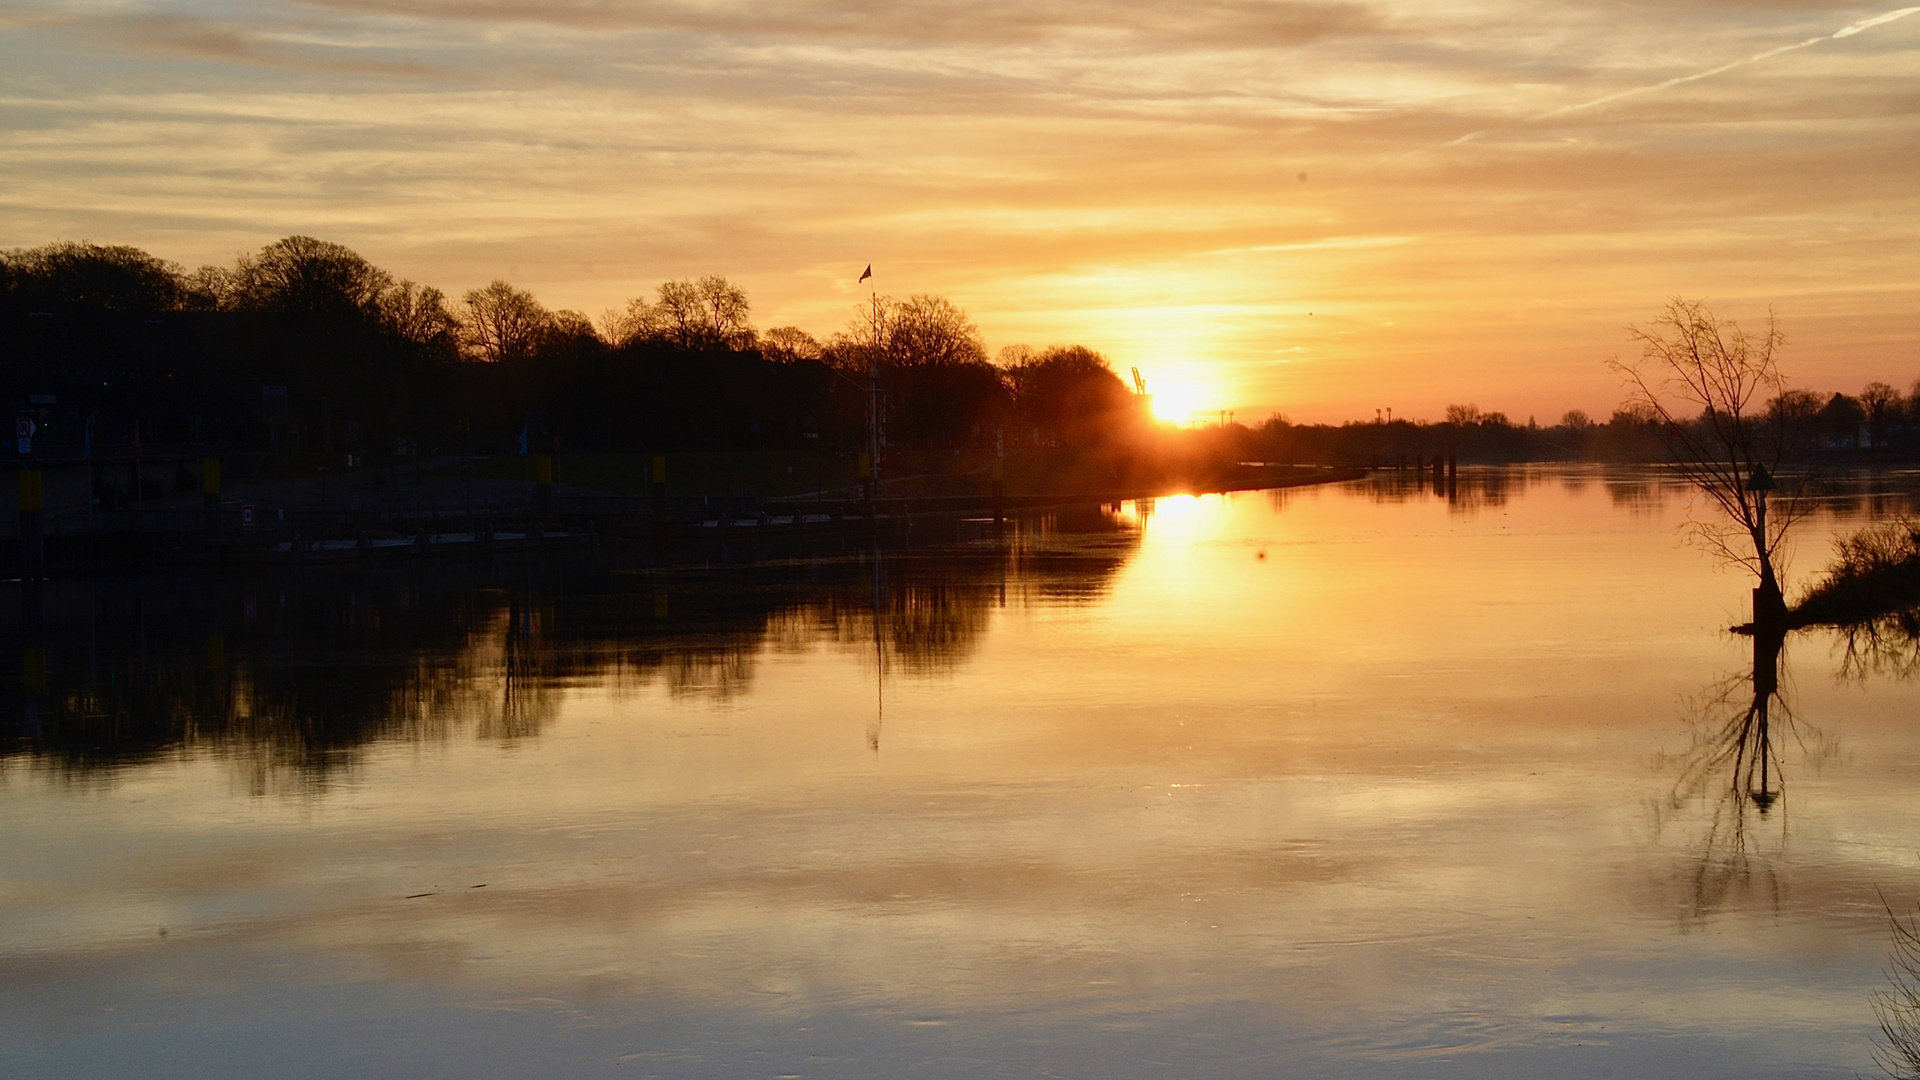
left=0, top=469, right=1920, bottom=1078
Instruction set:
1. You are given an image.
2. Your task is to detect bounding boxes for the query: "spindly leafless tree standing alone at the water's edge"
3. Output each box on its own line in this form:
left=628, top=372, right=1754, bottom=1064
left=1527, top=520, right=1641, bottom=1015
left=1607, top=298, right=1803, bottom=625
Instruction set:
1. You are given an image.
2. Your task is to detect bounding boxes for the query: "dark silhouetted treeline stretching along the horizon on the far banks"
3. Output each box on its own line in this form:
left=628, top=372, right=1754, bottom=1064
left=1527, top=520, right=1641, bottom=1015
left=0, top=236, right=1920, bottom=477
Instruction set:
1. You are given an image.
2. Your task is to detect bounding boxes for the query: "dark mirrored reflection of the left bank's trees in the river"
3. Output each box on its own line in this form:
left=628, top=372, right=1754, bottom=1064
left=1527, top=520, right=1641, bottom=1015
left=0, top=507, right=1139, bottom=792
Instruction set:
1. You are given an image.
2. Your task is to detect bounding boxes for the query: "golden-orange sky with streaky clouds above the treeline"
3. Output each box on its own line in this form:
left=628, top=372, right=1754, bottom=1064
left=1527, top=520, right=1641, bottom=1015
left=0, top=0, right=1920, bottom=423
